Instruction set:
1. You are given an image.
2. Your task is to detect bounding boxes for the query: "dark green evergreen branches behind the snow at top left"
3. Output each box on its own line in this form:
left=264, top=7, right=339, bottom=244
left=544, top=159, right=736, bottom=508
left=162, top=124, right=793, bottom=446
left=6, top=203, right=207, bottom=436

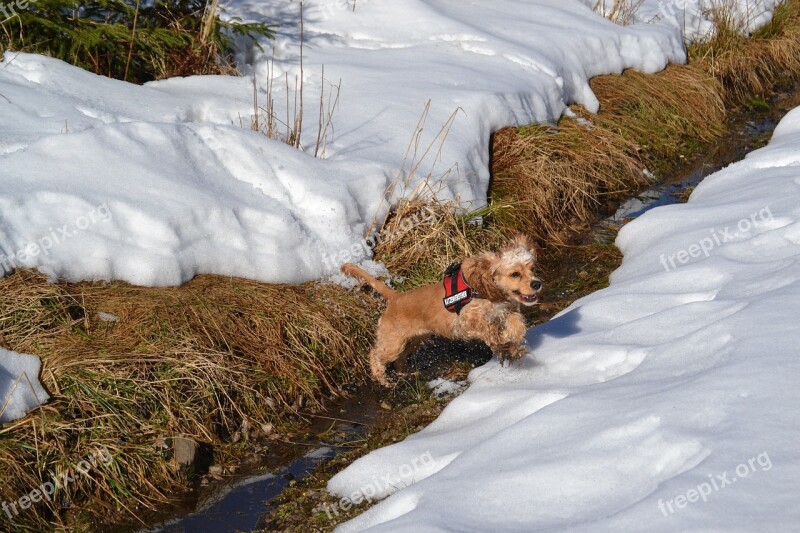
left=0, top=0, right=273, bottom=83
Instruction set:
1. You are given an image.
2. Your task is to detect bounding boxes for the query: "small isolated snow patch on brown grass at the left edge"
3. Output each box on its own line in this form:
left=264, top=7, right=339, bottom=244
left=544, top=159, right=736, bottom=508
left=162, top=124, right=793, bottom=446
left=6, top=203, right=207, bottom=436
left=0, top=348, right=50, bottom=424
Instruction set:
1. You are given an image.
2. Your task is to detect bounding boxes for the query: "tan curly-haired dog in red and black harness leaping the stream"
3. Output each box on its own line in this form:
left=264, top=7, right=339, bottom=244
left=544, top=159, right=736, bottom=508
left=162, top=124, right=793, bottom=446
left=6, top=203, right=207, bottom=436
left=342, top=235, right=542, bottom=385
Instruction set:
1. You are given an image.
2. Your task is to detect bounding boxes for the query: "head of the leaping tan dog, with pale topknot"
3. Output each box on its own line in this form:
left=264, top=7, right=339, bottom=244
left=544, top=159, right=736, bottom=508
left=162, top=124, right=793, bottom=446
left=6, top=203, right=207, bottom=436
left=463, top=234, right=542, bottom=305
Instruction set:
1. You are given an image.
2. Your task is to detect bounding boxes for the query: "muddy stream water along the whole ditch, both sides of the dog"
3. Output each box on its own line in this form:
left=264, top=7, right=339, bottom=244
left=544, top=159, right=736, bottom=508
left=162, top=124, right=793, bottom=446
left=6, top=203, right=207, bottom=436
left=133, top=88, right=800, bottom=533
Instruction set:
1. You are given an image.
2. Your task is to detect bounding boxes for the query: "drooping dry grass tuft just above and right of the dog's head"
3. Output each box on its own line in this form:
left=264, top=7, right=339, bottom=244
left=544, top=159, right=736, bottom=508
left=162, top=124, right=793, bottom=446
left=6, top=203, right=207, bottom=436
left=491, top=114, right=643, bottom=242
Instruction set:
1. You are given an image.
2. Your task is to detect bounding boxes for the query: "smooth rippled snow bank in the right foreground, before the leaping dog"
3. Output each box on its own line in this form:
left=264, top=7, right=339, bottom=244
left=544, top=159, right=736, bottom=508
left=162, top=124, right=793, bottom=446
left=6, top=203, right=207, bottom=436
left=328, top=104, right=800, bottom=532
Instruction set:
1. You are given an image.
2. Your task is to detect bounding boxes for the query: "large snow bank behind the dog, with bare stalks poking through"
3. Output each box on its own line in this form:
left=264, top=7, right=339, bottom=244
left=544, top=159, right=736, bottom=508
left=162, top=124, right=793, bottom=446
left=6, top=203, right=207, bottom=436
left=0, top=0, right=684, bottom=286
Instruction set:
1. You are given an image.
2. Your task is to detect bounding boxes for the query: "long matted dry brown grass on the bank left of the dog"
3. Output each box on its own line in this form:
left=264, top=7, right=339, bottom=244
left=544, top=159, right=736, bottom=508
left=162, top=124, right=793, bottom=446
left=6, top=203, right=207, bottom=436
left=0, top=272, right=374, bottom=529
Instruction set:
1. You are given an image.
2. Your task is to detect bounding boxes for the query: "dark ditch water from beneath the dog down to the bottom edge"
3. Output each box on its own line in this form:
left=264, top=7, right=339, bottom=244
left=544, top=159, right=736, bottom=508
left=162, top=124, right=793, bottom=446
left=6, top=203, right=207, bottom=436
left=125, top=338, right=492, bottom=533
